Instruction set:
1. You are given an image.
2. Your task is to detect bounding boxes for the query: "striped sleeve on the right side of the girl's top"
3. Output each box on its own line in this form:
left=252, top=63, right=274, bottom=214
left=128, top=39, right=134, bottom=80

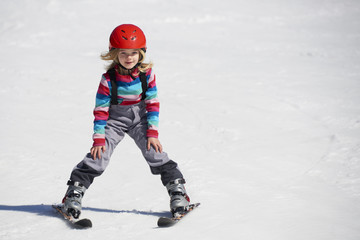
left=145, top=70, right=160, bottom=138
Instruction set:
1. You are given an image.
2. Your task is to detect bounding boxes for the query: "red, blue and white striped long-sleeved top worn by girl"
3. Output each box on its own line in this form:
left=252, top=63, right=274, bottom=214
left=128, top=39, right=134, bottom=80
left=93, top=69, right=159, bottom=146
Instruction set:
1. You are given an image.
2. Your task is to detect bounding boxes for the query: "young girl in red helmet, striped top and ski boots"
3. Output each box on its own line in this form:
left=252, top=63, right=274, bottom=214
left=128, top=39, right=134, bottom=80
left=63, top=24, right=189, bottom=218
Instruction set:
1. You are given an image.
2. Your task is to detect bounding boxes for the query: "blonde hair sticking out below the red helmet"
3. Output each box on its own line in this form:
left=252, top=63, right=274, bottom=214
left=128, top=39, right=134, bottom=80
left=100, top=48, right=153, bottom=74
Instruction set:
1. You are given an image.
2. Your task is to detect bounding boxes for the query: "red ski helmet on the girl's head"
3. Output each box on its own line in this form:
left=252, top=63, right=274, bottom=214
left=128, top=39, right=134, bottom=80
left=109, top=24, right=146, bottom=50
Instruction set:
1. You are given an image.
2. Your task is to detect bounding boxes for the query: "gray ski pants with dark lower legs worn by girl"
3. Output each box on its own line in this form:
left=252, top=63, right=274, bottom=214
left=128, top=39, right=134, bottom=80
left=70, top=101, right=183, bottom=188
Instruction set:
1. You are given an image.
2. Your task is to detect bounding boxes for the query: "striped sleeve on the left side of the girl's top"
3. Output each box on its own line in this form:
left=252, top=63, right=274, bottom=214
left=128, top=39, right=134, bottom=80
left=93, top=74, right=111, bottom=146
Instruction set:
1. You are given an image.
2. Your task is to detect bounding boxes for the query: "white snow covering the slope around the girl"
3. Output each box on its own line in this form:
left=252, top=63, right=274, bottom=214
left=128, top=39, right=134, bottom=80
left=0, top=0, right=360, bottom=240
